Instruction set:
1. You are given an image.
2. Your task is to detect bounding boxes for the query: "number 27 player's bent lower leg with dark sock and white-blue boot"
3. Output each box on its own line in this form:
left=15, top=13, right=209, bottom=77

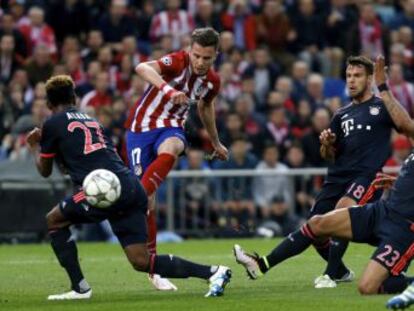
left=124, top=244, right=231, bottom=297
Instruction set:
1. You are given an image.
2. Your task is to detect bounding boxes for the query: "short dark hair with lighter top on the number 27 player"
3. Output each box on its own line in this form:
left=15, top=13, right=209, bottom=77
left=46, top=75, right=75, bottom=107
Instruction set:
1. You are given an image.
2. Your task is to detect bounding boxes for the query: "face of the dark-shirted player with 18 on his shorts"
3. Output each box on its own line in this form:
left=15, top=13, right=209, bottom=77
left=346, top=65, right=372, bottom=98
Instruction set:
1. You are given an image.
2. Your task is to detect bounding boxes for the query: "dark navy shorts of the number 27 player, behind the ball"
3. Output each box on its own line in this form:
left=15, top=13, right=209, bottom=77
left=59, top=172, right=148, bottom=247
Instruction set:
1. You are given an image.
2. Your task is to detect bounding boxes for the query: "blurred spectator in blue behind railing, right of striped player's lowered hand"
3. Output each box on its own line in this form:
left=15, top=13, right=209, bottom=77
left=217, top=136, right=257, bottom=227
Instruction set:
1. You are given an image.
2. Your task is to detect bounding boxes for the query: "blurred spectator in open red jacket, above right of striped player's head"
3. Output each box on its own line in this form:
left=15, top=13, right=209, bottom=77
left=221, top=0, right=256, bottom=51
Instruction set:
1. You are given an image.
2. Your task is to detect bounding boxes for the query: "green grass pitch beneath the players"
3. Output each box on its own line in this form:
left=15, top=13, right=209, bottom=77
left=0, top=240, right=402, bottom=311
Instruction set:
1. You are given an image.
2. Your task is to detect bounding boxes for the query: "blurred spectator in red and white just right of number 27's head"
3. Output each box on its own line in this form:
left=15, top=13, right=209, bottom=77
left=80, top=71, right=112, bottom=111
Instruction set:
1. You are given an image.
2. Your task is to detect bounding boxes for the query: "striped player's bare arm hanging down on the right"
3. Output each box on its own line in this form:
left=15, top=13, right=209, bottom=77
left=197, top=98, right=229, bottom=160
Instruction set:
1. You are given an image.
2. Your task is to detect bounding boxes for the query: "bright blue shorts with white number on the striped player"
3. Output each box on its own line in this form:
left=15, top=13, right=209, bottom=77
left=126, top=127, right=187, bottom=177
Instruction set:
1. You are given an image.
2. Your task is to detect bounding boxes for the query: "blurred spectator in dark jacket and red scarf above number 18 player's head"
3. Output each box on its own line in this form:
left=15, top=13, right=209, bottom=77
left=347, top=2, right=389, bottom=59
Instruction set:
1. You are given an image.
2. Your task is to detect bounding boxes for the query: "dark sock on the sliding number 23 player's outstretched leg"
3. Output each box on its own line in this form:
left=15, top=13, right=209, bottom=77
left=258, top=224, right=315, bottom=273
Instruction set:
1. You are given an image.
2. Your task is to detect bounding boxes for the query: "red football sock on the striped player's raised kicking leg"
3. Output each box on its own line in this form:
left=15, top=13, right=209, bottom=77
left=141, top=153, right=175, bottom=196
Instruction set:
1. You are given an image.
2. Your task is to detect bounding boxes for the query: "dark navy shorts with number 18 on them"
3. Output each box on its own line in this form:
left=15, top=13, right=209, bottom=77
left=309, top=175, right=382, bottom=217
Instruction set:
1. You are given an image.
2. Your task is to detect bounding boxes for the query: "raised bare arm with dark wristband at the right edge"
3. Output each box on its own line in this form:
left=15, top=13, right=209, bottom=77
left=374, top=55, right=414, bottom=138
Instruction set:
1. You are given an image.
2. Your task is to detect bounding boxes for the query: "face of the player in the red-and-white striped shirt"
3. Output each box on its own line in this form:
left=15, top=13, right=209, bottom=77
left=190, top=43, right=217, bottom=76
